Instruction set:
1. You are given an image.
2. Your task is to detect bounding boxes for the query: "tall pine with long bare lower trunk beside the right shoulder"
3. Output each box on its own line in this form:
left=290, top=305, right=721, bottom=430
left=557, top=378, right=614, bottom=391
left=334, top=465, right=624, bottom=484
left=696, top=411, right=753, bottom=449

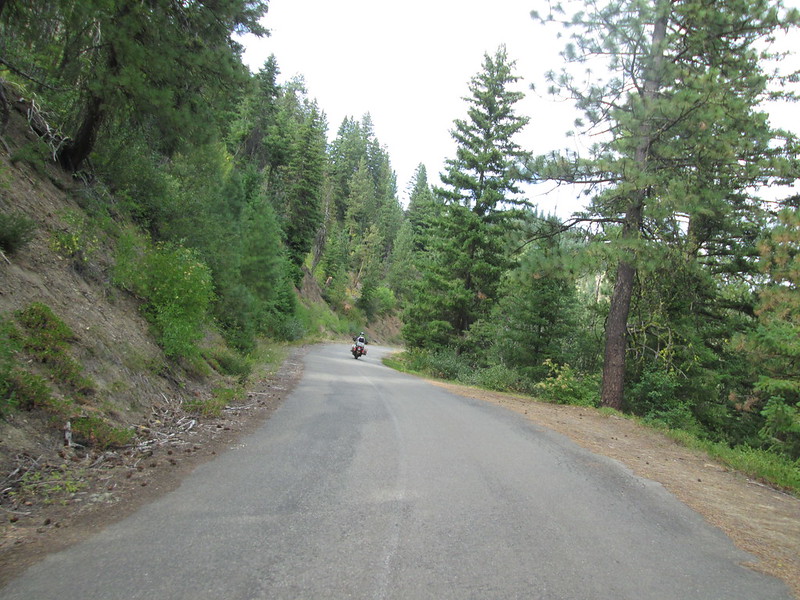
left=540, top=0, right=796, bottom=408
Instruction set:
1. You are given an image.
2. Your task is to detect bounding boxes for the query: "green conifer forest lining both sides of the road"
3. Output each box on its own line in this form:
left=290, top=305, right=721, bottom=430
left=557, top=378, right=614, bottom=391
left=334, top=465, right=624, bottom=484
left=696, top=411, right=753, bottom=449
left=0, top=0, right=800, bottom=485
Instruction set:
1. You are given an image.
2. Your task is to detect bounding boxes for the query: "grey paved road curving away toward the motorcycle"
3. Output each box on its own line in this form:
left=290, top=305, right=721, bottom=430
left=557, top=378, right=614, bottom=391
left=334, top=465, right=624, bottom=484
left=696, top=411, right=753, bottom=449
left=0, top=345, right=791, bottom=600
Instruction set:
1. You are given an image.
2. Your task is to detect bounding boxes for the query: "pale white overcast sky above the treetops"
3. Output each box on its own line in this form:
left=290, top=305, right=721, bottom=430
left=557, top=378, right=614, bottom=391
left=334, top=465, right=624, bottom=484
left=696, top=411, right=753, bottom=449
left=238, top=0, right=800, bottom=217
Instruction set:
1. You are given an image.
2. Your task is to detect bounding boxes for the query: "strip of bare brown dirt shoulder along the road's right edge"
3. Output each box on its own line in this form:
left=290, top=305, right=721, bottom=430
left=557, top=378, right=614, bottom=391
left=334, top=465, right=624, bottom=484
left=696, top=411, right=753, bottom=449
left=432, top=382, right=800, bottom=598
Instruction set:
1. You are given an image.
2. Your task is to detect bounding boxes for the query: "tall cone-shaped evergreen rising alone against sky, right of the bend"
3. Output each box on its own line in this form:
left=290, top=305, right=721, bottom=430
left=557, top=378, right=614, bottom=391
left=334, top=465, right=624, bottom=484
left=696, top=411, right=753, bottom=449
left=404, top=46, right=529, bottom=345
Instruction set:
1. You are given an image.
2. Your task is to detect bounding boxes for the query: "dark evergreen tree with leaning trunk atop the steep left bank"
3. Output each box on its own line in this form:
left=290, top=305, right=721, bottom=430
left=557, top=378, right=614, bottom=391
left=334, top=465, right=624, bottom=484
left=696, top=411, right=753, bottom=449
left=0, top=0, right=267, bottom=170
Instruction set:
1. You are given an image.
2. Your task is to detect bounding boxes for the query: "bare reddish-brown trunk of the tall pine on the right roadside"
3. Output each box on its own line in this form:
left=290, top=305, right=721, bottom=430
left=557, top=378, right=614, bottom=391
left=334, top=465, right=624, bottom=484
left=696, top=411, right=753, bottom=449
left=600, top=0, right=670, bottom=409
